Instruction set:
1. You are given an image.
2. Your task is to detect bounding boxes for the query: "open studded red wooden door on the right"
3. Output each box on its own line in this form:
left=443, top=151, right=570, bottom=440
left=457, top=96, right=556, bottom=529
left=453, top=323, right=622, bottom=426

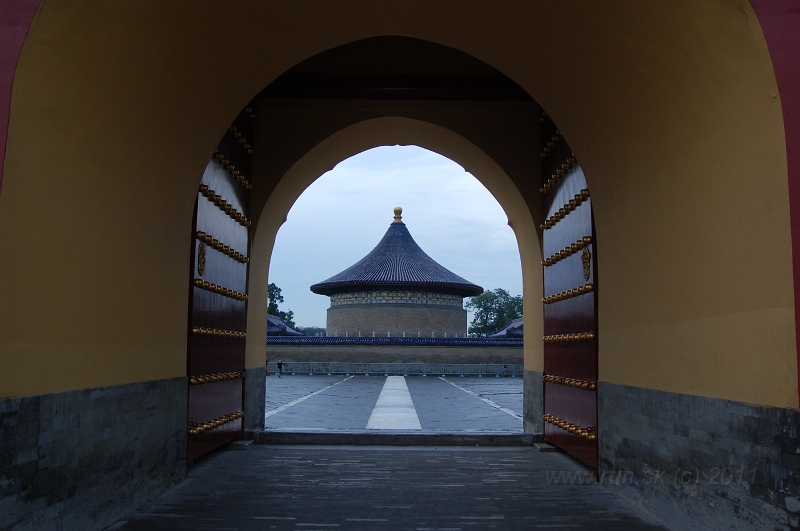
left=540, top=113, right=597, bottom=468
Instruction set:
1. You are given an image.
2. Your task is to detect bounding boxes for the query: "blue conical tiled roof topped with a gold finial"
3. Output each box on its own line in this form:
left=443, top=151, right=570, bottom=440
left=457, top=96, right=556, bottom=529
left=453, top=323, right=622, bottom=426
left=311, top=207, right=483, bottom=297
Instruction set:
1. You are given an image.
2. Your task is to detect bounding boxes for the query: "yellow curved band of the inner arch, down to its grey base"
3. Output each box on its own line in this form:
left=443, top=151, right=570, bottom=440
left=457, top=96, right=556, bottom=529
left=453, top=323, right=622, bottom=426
left=247, top=116, right=542, bottom=378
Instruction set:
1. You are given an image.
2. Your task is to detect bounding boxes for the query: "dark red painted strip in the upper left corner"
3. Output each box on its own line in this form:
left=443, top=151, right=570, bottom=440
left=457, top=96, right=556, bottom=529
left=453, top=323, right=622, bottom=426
left=0, top=0, right=40, bottom=197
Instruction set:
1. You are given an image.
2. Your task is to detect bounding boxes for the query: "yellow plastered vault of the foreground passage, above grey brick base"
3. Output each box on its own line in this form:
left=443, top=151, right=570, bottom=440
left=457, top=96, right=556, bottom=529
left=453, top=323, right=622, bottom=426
left=0, top=0, right=797, bottom=406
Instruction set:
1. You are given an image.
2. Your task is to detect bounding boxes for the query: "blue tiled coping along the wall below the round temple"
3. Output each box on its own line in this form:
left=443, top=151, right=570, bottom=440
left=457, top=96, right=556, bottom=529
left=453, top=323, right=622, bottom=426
left=267, top=335, right=522, bottom=347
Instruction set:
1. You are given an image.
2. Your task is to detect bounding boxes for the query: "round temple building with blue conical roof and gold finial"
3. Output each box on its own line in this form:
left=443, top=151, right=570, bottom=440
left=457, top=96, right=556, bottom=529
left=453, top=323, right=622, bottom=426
left=311, top=207, right=483, bottom=337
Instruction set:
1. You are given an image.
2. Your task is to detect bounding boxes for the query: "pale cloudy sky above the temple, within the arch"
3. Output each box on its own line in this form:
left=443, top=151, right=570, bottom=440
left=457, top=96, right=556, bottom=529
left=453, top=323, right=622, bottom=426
left=269, top=146, right=522, bottom=327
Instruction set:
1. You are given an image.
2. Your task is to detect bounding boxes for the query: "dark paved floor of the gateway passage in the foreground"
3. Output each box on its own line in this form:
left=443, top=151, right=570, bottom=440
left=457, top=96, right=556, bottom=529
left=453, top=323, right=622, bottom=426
left=112, top=445, right=662, bottom=531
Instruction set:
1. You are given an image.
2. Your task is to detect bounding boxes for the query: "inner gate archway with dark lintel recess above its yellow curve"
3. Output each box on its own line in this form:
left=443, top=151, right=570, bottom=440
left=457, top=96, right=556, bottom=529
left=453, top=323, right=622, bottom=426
left=183, top=37, right=564, bottom=464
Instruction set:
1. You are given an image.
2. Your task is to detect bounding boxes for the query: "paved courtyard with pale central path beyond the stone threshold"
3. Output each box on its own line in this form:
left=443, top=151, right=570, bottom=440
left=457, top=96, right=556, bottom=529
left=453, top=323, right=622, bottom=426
left=266, top=375, right=522, bottom=432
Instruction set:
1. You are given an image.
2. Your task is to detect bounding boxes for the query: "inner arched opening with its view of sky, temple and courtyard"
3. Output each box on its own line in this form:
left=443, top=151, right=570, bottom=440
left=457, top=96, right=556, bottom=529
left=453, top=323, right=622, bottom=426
left=258, top=146, right=529, bottom=432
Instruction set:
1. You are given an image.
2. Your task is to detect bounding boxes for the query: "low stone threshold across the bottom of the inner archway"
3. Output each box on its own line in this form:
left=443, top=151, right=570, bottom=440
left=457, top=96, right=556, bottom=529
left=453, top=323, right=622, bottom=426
left=254, top=430, right=534, bottom=446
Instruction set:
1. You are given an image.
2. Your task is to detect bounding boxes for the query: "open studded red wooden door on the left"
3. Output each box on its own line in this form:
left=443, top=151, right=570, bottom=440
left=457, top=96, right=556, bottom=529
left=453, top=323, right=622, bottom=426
left=187, top=109, right=253, bottom=464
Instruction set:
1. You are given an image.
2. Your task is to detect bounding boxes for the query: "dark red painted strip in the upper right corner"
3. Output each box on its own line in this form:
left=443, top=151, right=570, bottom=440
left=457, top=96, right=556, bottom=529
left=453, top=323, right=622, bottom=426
left=751, top=0, right=800, bottom=404
